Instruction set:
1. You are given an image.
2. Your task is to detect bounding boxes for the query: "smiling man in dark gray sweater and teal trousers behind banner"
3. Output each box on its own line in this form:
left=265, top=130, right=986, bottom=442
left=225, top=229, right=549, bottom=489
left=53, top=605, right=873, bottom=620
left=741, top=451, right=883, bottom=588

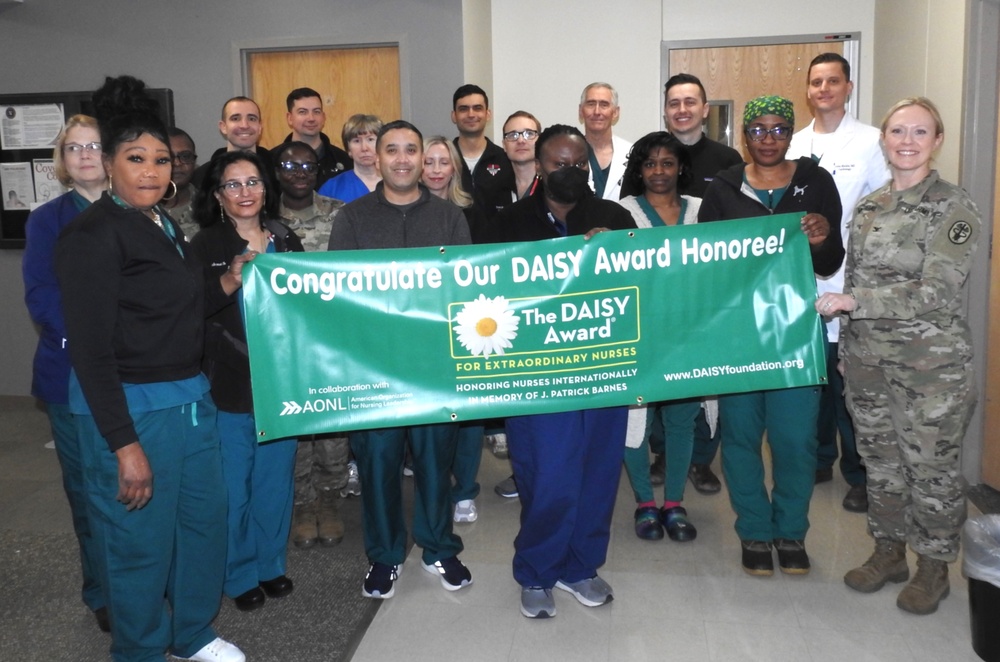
left=329, top=120, right=472, bottom=599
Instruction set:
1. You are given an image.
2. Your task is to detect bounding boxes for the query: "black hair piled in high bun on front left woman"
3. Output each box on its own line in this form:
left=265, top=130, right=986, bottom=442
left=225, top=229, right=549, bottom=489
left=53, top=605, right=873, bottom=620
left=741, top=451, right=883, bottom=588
left=91, top=76, right=170, bottom=156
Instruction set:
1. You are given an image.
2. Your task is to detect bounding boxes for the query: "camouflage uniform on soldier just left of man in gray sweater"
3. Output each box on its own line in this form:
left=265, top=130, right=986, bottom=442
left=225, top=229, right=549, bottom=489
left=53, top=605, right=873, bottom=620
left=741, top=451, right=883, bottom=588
left=278, top=193, right=350, bottom=505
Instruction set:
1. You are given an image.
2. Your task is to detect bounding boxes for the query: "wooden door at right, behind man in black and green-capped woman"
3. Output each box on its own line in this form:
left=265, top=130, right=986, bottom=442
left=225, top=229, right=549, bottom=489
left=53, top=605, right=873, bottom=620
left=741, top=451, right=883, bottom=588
left=670, top=41, right=844, bottom=160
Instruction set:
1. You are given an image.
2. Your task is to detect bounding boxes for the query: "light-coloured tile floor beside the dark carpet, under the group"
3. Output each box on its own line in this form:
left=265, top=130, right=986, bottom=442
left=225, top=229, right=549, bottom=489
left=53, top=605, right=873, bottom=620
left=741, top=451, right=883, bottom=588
left=353, top=450, right=979, bottom=662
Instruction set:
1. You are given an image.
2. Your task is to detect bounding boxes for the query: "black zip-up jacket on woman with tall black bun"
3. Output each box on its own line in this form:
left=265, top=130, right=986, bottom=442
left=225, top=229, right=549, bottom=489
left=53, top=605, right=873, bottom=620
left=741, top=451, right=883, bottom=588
left=55, top=192, right=225, bottom=451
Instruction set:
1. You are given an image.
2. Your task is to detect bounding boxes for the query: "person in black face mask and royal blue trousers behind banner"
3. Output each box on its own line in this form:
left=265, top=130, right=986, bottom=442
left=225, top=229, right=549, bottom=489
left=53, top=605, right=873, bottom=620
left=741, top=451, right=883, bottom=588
left=490, top=124, right=635, bottom=618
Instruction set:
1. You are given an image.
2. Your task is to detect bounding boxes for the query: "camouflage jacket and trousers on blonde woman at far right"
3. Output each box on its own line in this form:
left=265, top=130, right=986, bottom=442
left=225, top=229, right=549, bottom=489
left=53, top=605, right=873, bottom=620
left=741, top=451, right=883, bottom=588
left=840, top=171, right=981, bottom=562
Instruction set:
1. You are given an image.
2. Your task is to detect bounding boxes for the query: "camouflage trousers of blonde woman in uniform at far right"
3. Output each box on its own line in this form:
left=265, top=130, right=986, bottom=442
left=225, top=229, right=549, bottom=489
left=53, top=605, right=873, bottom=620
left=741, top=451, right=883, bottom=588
left=845, top=356, right=976, bottom=562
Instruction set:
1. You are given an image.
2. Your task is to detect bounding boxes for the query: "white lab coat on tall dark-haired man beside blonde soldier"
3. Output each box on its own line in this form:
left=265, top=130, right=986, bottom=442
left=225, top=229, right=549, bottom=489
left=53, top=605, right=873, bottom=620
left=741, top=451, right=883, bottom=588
left=785, top=113, right=891, bottom=342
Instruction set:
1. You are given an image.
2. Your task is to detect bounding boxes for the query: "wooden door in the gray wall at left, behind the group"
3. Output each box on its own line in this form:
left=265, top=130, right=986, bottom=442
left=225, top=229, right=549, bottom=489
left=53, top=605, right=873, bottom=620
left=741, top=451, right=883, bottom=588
left=247, top=46, right=401, bottom=152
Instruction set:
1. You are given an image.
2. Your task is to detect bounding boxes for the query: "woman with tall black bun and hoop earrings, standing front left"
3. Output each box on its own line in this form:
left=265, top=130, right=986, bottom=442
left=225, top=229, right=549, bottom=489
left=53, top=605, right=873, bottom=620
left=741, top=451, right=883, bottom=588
left=55, top=76, right=251, bottom=662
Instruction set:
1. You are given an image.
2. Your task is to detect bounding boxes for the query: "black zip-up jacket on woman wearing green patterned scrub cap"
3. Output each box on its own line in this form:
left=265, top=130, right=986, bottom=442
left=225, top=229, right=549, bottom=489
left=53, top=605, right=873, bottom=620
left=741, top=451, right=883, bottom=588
left=698, top=156, right=844, bottom=277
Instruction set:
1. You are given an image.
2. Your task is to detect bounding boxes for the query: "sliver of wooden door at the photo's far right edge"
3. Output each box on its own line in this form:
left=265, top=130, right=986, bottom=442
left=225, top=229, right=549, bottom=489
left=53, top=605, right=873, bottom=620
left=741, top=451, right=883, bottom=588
left=979, top=100, right=1000, bottom=490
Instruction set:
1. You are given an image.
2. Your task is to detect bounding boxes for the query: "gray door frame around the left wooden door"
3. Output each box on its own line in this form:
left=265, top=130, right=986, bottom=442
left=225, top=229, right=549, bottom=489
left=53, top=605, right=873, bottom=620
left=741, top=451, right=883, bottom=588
left=230, top=34, right=412, bottom=117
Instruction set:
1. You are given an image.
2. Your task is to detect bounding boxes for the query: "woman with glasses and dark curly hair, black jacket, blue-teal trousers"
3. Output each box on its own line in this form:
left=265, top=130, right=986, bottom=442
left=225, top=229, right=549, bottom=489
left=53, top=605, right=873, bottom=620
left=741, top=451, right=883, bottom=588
left=191, top=152, right=303, bottom=611
